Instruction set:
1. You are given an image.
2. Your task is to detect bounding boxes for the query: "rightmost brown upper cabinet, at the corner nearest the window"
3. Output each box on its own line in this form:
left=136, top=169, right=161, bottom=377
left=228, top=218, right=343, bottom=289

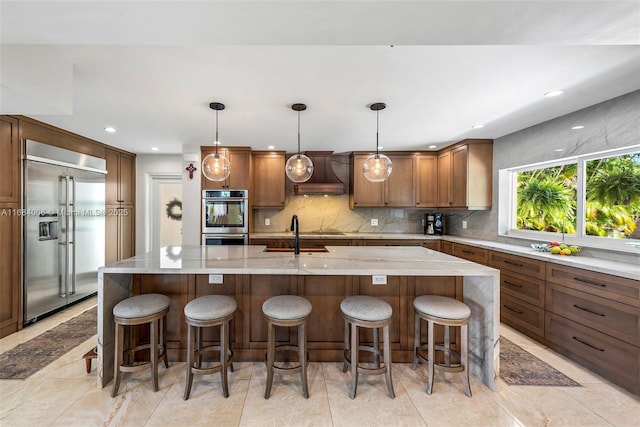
left=438, top=139, right=493, bottom=210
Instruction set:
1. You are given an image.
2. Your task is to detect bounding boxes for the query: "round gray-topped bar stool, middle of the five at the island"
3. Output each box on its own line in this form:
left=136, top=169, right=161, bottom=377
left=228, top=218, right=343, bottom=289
left=262, top=295, right=311, bottom=399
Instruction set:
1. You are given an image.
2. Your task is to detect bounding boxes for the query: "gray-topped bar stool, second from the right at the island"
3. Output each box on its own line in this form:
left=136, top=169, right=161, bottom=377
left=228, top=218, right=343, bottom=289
left=340, top=295, right=396, bottom=399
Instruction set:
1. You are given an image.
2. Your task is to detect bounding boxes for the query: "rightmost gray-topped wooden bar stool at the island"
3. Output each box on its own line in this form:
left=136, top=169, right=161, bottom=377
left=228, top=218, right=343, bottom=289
left=411, top=295, right=471, bottom=397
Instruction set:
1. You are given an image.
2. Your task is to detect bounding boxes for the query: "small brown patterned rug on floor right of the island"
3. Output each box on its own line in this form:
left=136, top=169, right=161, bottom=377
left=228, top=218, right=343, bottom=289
left=500, top=337, right=580, bottom=387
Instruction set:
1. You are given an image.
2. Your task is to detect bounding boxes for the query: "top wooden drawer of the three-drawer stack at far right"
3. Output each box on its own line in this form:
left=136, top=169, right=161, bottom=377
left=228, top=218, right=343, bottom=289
left=547, top=263, right=640, bottom=307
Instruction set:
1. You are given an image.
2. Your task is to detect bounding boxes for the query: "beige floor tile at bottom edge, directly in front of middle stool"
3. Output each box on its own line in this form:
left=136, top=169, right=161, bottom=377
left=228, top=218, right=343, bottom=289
left=239, top=376, right=331, bottom=427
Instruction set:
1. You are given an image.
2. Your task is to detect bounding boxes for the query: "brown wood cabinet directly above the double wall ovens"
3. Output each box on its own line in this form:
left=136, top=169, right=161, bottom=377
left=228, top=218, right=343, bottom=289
left=200, top=146, right=251, bottom=190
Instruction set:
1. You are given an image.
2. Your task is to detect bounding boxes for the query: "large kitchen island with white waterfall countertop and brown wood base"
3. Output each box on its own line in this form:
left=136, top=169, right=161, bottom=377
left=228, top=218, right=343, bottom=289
left=98, top=245, right=500, bottom=389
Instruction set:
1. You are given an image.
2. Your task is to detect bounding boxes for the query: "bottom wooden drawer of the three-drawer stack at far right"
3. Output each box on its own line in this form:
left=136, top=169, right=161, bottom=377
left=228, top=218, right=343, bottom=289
left=545, top=312, right=640, bottom=393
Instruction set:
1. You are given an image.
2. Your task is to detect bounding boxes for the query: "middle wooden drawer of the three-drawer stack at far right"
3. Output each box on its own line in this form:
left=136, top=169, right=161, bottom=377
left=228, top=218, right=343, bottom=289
left=546, top=283, right=640, bottom=346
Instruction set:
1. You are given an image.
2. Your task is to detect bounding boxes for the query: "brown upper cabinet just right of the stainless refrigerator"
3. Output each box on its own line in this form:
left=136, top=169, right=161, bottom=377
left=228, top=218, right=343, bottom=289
left=105, top=149, right=136, bottom=205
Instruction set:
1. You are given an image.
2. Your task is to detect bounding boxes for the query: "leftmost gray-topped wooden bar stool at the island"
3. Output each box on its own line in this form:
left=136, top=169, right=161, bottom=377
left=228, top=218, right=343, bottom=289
left=111, top=294, right=171, bottom=397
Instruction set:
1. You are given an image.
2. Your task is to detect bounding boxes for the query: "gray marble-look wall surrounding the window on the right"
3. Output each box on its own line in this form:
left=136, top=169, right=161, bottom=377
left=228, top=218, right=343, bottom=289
left=447, top=91, right=640, bottom=261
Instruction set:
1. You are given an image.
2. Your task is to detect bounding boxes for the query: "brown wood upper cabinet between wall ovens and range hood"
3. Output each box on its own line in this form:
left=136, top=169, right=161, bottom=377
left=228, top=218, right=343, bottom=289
left=250, top=151, right=285, bottom=209
